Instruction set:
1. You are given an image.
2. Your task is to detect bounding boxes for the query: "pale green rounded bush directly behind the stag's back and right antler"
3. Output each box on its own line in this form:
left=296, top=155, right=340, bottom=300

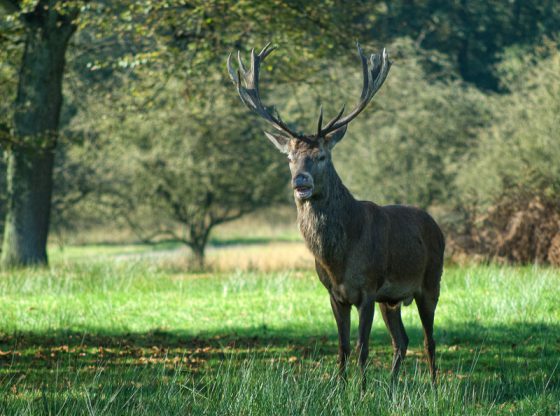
left=335, top=40, right=489, bottom=208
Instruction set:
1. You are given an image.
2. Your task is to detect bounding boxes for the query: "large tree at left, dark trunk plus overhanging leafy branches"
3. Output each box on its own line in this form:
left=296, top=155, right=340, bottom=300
left=0, top=0, right=372, bottom=266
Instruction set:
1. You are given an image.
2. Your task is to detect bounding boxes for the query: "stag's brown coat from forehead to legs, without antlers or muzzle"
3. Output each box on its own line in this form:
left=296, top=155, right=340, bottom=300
left=289, top=139, right=444, bottom=384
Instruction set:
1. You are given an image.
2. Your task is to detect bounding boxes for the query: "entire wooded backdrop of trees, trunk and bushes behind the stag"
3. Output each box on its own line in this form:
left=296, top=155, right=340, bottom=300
left=0, top=0, right=560, bottom=267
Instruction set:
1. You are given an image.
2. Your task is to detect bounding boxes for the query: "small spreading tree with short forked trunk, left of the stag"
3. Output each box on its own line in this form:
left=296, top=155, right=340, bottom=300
left=100, top=82, right=286, bottom=268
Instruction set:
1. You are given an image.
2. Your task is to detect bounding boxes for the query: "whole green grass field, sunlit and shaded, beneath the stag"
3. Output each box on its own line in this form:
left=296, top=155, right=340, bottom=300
left=0, top=257, right=560, bottom=415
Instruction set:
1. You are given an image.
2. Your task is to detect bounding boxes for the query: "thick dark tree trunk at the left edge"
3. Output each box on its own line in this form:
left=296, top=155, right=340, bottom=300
left=1, top=1, right=76, bottom=267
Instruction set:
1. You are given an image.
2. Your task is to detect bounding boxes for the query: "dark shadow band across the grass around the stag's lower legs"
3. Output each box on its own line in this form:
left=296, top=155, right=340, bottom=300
left=0, top=322, right=560, bottom=412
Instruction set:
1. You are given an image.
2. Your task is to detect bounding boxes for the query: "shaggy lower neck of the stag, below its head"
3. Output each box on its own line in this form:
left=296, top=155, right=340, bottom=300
left=296, top=165, right=357, bottom=265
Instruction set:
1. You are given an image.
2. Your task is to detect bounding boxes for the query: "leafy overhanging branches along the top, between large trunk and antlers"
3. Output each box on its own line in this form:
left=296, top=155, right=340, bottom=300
left=65, top=0, right=368, bottom=94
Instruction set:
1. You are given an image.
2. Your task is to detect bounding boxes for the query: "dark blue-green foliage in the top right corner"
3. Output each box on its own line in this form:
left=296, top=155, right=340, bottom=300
left=375, top=0, right=560, bottom=91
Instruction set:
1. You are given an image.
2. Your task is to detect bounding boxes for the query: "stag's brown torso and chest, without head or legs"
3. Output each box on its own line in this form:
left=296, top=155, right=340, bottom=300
left=296, top=189, right=443, bottom=306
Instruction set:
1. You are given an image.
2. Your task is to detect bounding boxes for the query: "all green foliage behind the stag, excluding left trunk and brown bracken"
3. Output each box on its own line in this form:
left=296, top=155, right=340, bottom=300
left=0, top=0, right=560, bottom=260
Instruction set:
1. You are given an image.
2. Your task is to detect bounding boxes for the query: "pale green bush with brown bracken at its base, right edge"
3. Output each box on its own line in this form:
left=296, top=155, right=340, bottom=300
left=456, top=44, right=560, bottom=264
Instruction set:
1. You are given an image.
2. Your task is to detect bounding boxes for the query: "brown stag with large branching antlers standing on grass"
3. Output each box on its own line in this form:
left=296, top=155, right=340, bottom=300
left=227, top=43, right=445, bottom=390
